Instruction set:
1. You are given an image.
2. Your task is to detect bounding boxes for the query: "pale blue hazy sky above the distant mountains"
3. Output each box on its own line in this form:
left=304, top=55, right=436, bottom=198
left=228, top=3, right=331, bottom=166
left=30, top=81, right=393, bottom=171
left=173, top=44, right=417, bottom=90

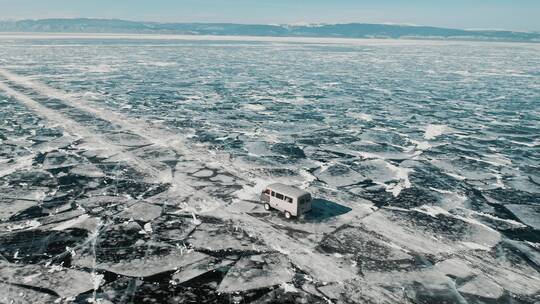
left=0, top=0, right=540, bottom=31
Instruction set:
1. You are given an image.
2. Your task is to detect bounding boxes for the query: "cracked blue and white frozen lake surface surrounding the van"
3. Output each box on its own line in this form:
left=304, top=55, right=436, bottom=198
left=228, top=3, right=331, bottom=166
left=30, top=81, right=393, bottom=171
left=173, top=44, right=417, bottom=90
left=0, top=37, right=540, bottom=304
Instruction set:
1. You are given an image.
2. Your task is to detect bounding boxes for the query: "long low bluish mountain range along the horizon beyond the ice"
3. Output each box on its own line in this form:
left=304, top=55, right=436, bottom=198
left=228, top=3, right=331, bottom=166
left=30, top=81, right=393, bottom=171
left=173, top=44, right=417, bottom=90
left=0, top=19, right=540, bottom=42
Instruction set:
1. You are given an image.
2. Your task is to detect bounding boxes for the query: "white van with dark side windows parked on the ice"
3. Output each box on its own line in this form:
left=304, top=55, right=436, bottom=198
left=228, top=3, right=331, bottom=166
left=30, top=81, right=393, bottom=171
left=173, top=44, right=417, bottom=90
left=261, top=183, right=311, bottom=219
